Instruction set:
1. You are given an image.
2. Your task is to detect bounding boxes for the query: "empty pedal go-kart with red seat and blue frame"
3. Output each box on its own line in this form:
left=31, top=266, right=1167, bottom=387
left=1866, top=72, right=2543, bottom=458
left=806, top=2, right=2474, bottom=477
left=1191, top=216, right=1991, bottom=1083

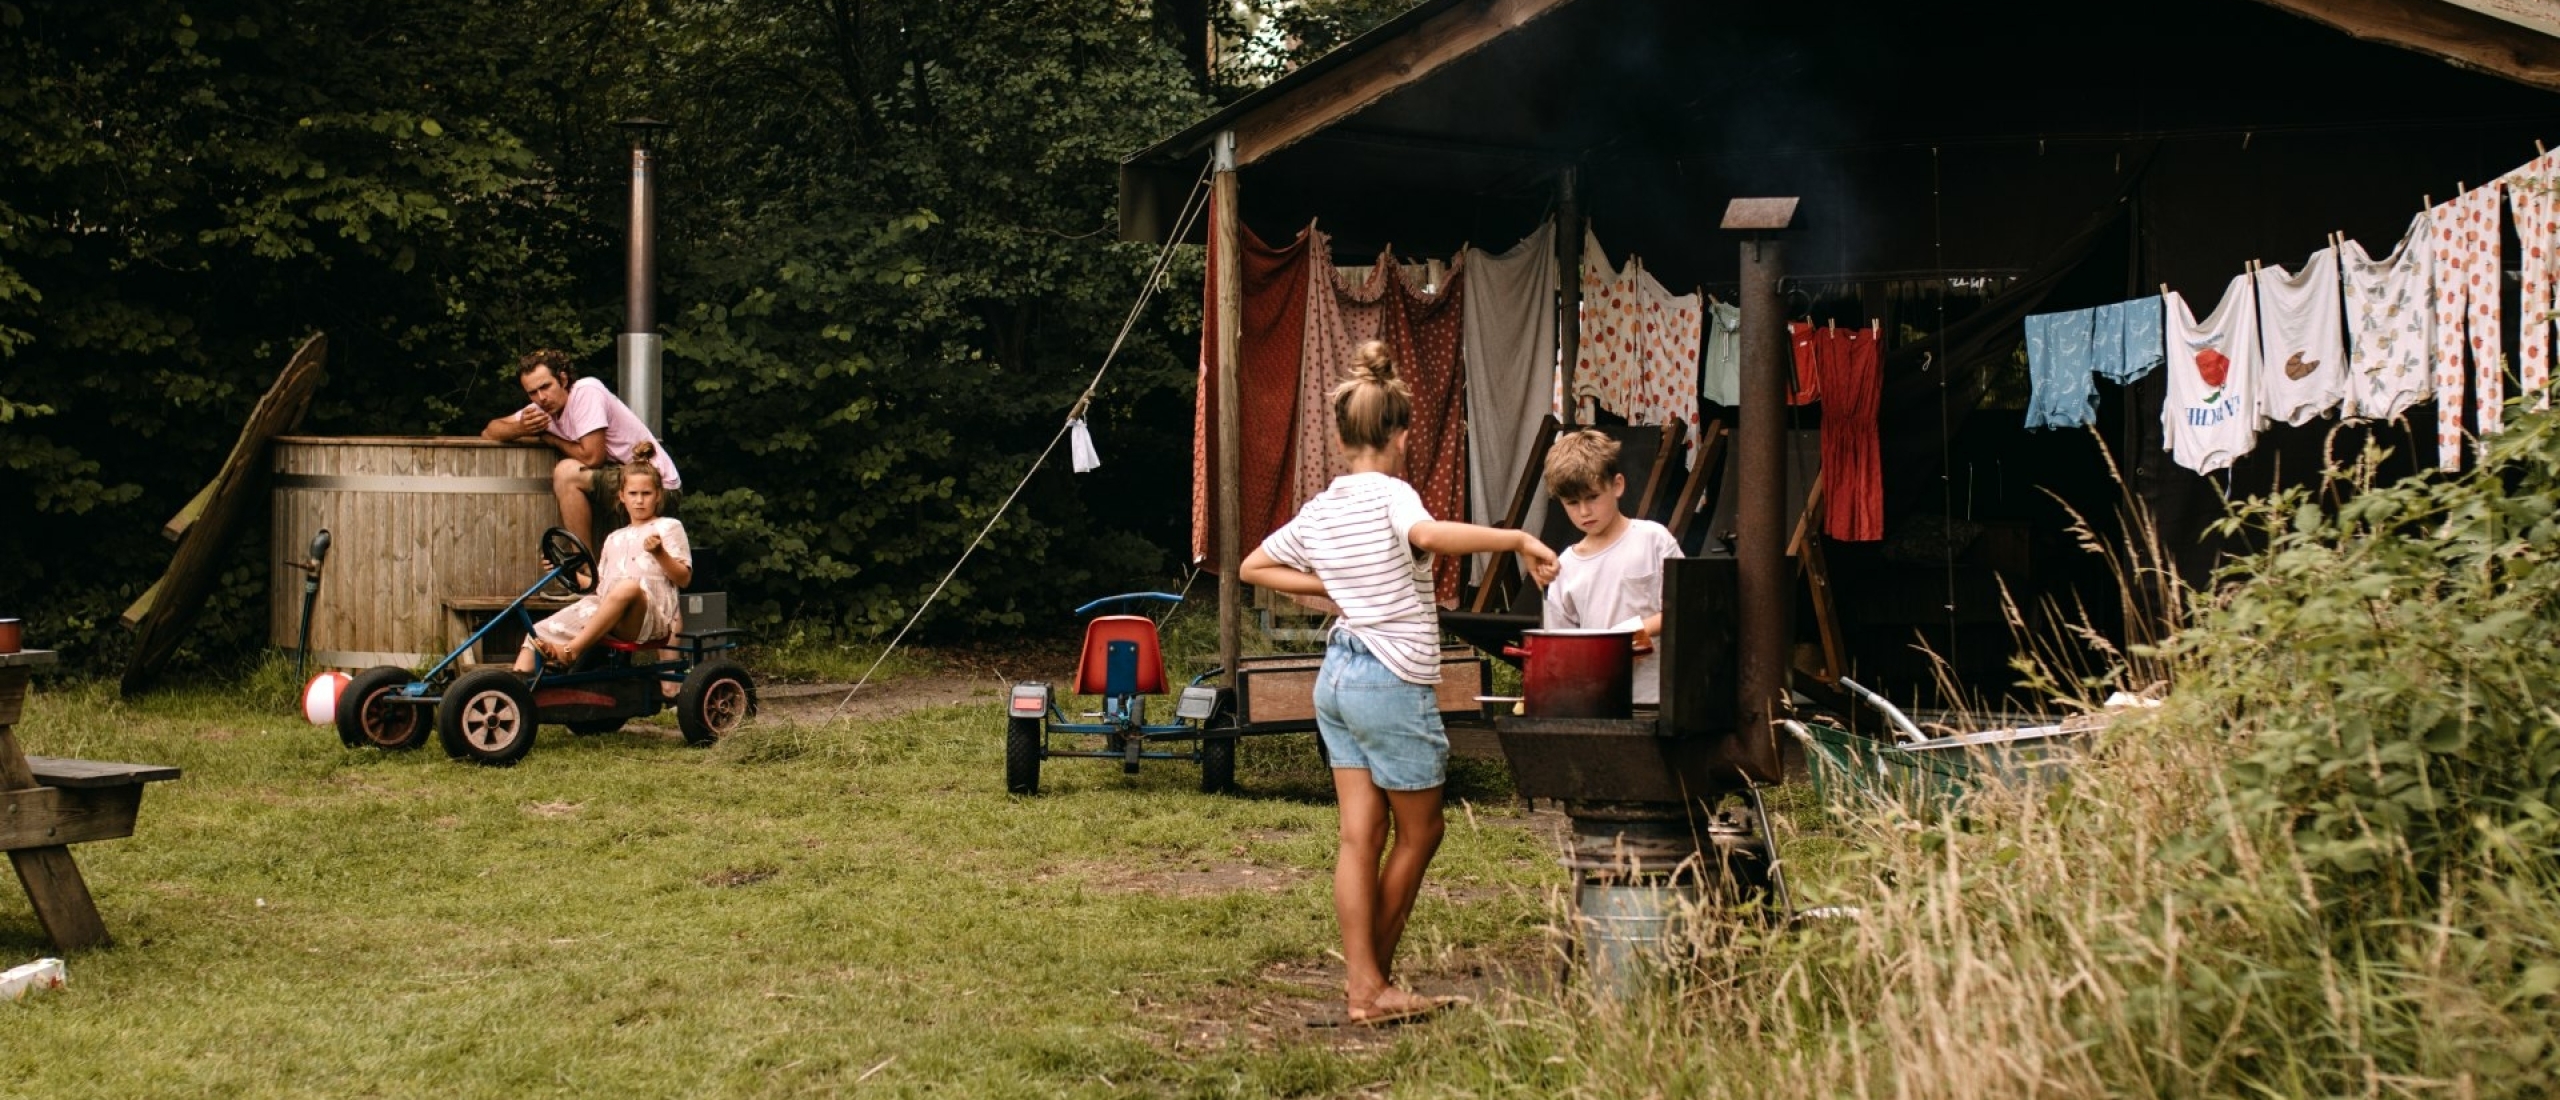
left=1004, top=591, right=1236, bottom=796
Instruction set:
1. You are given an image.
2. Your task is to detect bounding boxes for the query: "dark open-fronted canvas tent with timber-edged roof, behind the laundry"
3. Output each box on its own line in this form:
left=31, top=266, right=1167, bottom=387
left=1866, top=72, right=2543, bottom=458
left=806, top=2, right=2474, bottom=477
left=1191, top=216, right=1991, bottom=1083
left=1121, top=0, right=2560, bottom=706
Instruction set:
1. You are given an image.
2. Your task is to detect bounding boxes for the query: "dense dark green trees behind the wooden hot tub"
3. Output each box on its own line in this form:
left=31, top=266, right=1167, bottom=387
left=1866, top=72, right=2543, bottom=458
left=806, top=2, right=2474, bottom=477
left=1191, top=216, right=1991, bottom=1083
left=0, top=0, right=1443, bottom=675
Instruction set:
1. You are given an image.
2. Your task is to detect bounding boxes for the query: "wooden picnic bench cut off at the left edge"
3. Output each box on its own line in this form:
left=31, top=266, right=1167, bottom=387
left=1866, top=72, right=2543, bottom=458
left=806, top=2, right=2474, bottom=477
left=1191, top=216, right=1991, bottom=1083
left=0, top=650, right=179, bottom=952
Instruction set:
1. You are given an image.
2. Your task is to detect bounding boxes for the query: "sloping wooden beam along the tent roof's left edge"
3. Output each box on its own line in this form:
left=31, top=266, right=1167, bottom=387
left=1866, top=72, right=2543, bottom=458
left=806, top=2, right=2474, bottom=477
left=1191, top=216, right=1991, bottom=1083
left=1234, top=0, right=1572, bottom=166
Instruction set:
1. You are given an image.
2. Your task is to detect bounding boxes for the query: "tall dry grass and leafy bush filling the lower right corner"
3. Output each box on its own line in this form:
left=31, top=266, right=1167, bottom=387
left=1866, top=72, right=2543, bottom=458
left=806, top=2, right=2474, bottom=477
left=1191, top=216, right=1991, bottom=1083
left=1477, top=417, right=2560, bottom=1100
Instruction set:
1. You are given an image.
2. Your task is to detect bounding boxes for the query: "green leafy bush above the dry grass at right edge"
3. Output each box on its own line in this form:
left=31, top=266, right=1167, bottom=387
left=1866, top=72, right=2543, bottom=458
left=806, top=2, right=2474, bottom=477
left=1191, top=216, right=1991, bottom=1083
left=2179, top=414, right=2560, bottom=918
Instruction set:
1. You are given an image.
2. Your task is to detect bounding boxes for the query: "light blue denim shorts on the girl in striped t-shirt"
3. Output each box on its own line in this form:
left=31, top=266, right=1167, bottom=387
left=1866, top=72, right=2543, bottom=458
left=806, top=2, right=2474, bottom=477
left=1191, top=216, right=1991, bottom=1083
left=1316, top=632, right=1449, bottom=790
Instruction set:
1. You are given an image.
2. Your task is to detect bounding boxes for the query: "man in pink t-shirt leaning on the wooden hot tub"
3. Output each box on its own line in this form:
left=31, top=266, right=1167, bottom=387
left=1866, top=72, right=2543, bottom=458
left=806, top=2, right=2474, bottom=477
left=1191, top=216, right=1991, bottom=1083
left=481, top=348, right=684, bottom=545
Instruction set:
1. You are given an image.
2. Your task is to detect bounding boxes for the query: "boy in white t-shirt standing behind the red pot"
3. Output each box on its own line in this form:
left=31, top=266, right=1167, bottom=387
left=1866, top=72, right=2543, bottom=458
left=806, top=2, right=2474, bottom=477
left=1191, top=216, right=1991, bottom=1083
left=1544, top=430, right=1682, bottom=706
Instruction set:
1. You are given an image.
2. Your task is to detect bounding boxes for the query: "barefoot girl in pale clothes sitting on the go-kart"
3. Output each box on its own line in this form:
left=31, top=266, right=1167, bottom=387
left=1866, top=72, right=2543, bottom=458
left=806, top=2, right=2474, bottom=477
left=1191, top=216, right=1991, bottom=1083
left=515, top=443, right=694, bottom=673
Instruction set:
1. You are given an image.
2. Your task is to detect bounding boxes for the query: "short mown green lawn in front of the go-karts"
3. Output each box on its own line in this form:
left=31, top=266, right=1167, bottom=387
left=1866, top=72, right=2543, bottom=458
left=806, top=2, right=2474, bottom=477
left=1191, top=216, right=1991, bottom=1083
left=0, top=665, right=1562, bottom=1095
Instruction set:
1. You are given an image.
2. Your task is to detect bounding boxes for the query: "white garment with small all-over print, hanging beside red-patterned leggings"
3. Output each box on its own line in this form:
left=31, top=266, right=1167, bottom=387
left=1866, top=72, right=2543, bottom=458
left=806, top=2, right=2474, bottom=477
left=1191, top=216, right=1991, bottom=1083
left=2337, top=210, right=2435, bottom=420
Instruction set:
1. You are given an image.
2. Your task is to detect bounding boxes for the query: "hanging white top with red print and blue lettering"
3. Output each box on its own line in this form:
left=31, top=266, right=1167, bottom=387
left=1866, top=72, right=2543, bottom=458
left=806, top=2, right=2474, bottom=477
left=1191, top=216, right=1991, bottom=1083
left=2161, top=271, right=2258, bottom=473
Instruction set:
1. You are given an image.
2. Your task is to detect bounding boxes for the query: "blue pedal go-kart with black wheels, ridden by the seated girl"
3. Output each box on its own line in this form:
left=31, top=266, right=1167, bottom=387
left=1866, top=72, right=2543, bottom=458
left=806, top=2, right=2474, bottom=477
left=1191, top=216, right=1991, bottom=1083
left=338, top=527, right=755, bottom=765
